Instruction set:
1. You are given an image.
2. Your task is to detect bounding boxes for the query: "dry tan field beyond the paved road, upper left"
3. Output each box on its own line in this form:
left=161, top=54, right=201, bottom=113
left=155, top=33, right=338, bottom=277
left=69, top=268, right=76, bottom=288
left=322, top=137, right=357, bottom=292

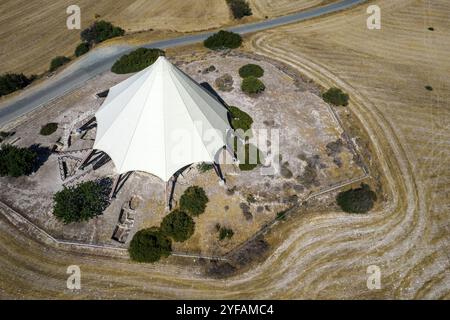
left=0, top=0, right=231, bottom=74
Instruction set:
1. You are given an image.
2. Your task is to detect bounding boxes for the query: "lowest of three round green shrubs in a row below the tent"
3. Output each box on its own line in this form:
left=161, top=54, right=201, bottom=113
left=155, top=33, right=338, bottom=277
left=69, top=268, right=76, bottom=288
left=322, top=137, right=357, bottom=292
left=128, top=228, right=172, bottom=262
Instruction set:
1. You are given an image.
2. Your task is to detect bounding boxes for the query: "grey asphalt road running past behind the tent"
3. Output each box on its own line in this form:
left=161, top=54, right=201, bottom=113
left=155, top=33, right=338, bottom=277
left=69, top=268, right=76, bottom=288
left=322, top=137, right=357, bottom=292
left=0, top=0, right=366, bottom=126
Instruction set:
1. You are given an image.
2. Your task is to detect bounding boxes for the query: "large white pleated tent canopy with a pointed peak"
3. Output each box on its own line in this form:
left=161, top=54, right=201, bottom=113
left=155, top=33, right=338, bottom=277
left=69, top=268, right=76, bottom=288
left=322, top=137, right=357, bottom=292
left=94, top=57, right=230, bottom=181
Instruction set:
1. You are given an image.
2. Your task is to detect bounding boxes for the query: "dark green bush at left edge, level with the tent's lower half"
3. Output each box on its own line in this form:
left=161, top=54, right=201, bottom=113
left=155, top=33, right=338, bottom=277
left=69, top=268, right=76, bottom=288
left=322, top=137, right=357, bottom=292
left=0, top=144, right=37, bottom=177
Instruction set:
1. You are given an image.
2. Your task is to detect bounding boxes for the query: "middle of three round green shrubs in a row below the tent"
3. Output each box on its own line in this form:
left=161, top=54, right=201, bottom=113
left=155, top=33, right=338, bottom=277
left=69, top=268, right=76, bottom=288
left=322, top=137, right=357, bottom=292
left=161, top=210, right=195, bottom=242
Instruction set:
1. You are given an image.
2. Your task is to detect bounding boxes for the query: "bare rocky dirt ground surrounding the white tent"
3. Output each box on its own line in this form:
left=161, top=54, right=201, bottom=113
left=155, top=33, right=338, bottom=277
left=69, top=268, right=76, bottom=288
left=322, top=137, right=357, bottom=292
left=0, top=53, right=364, bottom=256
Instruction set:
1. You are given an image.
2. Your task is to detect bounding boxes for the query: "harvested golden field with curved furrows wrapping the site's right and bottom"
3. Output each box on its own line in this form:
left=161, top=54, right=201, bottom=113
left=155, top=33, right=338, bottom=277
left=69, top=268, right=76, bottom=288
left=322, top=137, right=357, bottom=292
left=0, top=0, right=450, bottom=299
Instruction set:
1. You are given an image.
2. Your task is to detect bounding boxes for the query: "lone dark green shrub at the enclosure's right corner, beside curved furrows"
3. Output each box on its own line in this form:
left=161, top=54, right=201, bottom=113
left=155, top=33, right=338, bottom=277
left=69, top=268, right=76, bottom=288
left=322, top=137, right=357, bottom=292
left=336, top=184, right=377, bottom=213
